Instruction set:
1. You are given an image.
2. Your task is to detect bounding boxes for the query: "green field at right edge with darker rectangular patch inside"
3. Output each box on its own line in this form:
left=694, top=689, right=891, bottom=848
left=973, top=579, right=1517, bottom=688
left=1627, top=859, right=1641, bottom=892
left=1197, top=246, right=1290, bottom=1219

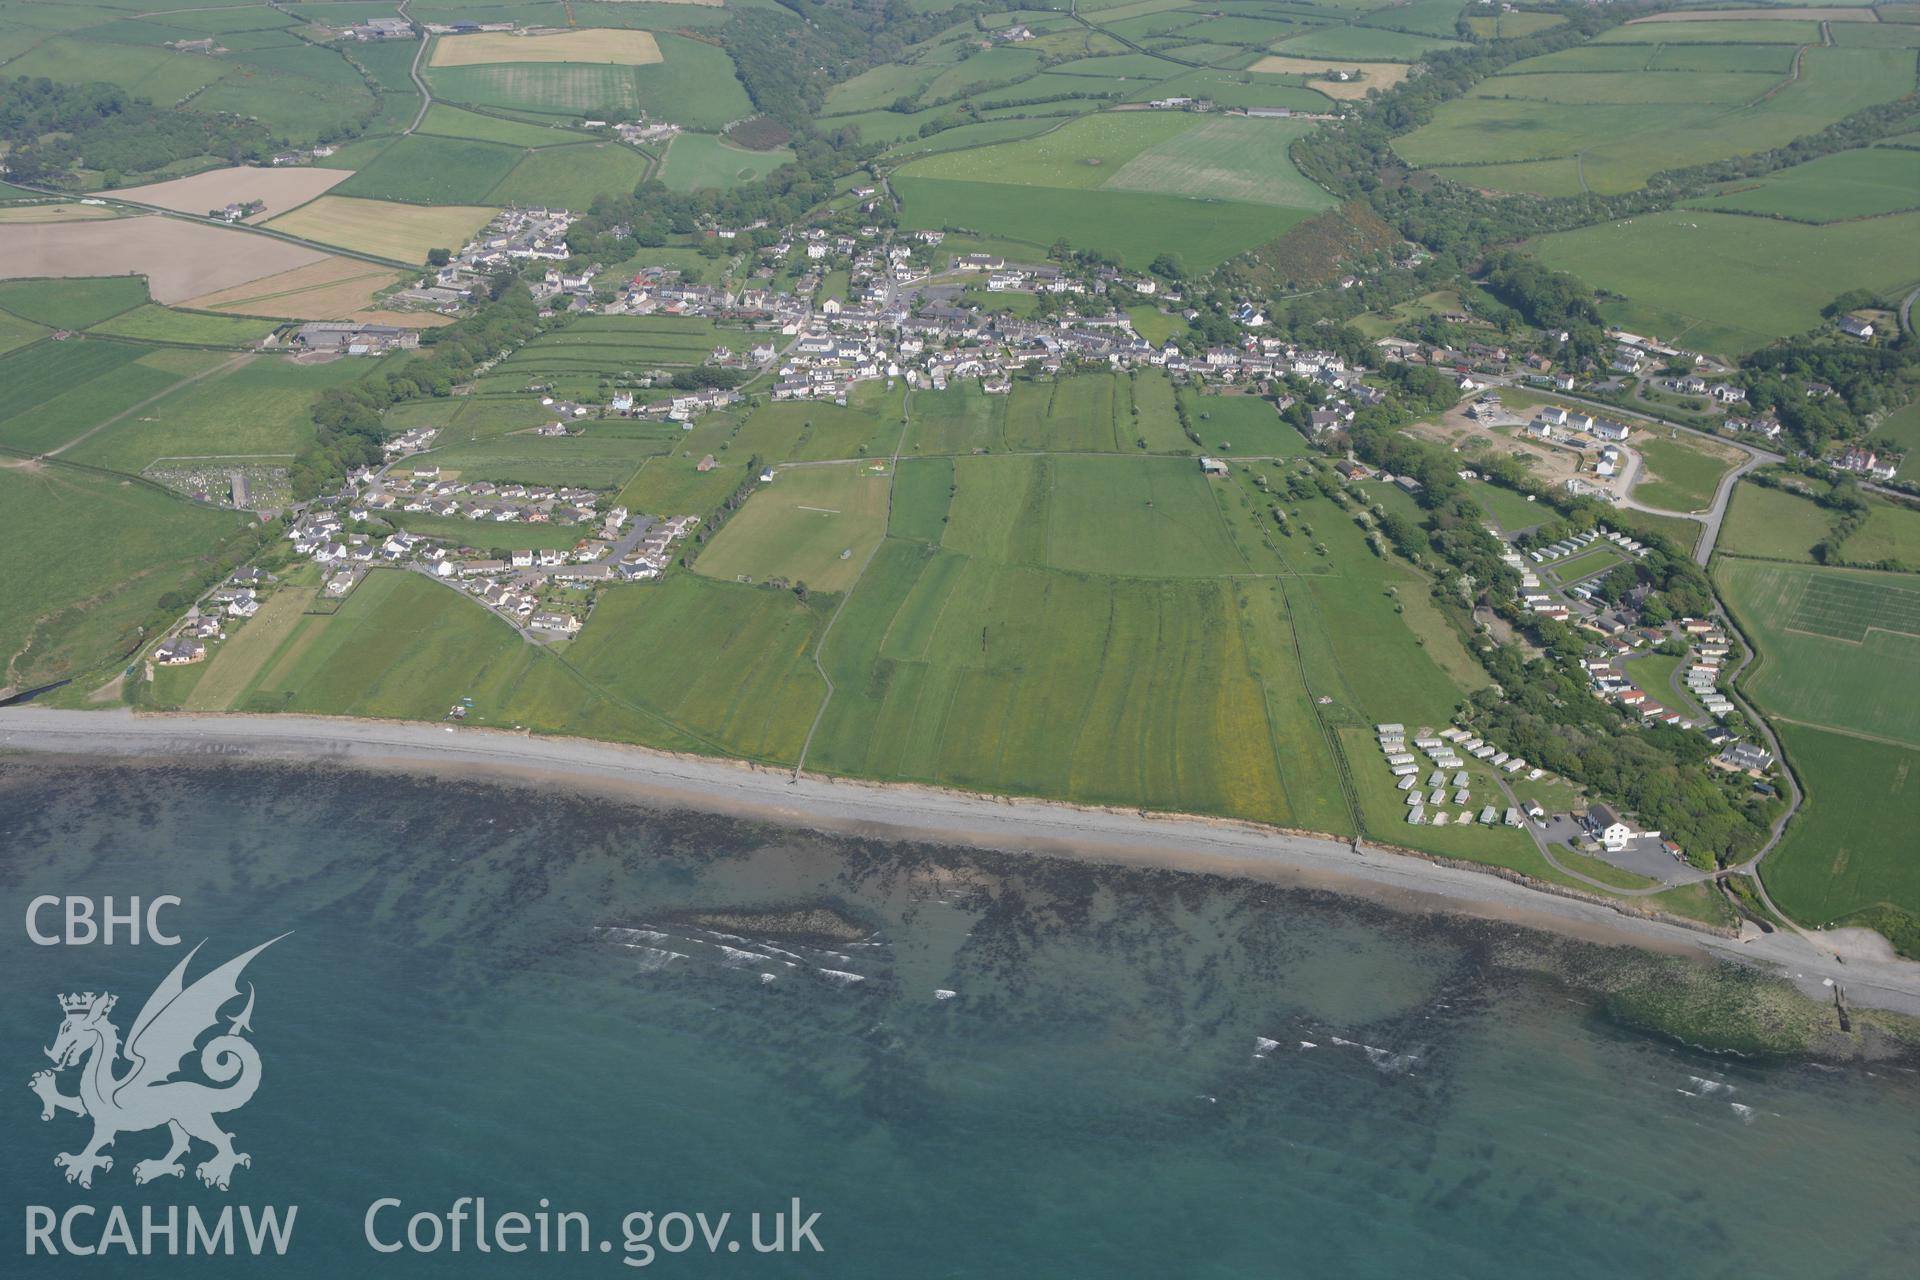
left=1715, top=560, right=1920, bottom=748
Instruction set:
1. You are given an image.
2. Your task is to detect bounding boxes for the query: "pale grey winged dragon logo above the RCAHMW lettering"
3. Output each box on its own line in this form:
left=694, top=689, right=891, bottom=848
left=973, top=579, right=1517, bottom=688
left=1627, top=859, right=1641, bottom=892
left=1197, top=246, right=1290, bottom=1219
left=27, top=935, right=286, bottom=1192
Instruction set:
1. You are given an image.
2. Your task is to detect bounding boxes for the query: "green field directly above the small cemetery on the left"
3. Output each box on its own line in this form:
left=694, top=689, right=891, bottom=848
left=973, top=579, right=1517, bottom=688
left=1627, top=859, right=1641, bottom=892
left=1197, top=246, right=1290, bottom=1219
left=73, top=355, right=367, bottom=472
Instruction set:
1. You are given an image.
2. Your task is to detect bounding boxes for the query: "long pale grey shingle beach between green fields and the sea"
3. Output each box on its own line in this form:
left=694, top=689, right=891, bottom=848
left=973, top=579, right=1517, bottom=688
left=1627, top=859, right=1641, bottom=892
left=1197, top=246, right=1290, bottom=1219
left=11, top=706, right=1920, bottom=1015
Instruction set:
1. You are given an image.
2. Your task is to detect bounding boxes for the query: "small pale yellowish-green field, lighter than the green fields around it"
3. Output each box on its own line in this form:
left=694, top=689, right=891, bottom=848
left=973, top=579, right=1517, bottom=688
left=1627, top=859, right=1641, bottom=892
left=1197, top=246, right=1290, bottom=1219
left=695, top=462, right=891, bottom=591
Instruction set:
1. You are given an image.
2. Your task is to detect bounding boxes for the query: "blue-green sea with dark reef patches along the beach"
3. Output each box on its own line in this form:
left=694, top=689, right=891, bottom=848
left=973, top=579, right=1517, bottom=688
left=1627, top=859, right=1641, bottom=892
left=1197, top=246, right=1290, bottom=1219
left=0, top=760, right=1920, bottom=1280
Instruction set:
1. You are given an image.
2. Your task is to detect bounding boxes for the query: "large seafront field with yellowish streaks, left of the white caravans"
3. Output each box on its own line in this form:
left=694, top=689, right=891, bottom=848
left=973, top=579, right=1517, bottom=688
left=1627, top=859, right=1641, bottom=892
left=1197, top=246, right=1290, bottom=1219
left=794, top=539, right=1342, bottom=825
